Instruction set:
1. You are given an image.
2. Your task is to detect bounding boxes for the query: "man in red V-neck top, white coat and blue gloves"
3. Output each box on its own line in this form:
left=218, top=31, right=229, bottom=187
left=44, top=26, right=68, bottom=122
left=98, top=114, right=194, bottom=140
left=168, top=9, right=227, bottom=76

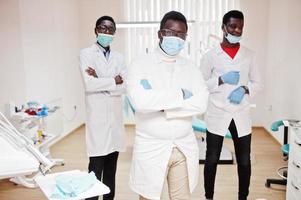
left=201, top=10, right=262, bottom=200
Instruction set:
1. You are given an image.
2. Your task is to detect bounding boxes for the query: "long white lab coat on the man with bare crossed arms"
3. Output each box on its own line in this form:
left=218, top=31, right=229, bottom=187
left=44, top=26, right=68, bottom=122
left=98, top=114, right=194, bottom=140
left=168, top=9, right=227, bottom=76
left=80, top=44, right=126, bottom=157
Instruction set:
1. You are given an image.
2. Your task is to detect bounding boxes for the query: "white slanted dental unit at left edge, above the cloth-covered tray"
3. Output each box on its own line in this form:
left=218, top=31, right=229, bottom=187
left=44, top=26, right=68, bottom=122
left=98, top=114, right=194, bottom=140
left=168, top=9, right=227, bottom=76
left=0, top=112, right=55, bottom=188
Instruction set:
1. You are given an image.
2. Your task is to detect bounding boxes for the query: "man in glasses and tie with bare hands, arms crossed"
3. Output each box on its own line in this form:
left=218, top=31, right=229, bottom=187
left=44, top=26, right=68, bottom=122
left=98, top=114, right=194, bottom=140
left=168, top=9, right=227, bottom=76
left=80, top=16, right=126, bottom=200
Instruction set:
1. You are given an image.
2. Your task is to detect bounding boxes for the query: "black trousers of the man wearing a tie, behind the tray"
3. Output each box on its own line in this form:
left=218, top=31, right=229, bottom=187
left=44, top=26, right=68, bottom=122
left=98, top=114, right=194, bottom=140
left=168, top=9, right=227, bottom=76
left=88, top=152, right=118, bottom=200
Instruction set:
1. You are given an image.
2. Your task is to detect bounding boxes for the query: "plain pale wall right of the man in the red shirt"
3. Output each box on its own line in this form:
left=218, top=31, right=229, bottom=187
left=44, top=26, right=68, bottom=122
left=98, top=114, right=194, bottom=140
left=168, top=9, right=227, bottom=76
left=241, top=0, right=301, bottom=142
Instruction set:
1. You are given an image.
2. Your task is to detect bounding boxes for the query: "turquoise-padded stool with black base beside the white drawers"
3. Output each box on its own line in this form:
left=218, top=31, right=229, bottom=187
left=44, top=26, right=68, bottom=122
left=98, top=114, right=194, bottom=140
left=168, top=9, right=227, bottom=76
left=265, top=120, right=289, bottom=188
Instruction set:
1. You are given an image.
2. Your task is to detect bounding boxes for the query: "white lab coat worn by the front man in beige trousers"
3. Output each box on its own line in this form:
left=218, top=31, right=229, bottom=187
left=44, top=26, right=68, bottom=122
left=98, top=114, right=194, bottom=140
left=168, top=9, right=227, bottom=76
left=127, top=48, right=208, bottom=200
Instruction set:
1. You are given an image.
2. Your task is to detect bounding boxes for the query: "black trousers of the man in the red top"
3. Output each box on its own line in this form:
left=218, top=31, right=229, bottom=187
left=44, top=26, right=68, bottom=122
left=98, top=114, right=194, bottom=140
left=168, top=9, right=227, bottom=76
left=204, top=119, right=251, bottom=200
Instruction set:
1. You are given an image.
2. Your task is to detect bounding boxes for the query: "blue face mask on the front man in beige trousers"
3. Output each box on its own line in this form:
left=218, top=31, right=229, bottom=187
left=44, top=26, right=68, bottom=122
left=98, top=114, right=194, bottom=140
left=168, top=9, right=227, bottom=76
left=161, top=36, right=185, bottom=56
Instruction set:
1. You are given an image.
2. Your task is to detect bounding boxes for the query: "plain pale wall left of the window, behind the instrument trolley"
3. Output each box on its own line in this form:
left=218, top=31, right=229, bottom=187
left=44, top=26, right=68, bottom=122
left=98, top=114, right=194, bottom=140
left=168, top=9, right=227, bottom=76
left=0, top=0, right=84, bottom=138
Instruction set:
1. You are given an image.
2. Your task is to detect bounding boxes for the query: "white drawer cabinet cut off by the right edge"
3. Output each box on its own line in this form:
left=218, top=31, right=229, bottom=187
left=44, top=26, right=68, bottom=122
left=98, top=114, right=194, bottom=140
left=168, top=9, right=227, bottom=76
left=286, top=127, right=301, bottom=200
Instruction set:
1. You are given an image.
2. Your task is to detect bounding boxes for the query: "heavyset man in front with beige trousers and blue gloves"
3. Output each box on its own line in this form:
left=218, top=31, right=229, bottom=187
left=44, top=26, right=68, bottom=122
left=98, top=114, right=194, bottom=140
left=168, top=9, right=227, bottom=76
left=127, top=11, right=208, bottom=200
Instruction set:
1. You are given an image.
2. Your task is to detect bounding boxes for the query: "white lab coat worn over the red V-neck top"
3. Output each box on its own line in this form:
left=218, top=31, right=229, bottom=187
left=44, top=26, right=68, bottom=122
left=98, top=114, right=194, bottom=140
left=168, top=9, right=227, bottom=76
left=201, top=45, right=263, bottom=137
